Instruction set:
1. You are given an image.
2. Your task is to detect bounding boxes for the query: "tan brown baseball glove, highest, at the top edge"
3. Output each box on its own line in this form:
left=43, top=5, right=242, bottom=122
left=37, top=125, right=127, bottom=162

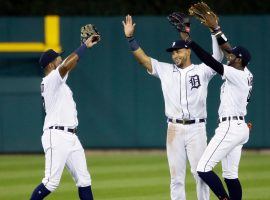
left=188, top=2, right=218, bottom=29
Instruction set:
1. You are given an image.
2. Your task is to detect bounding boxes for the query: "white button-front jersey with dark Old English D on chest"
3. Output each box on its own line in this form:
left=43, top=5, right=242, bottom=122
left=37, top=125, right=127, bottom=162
left=151, top=58, right=215, bottom=119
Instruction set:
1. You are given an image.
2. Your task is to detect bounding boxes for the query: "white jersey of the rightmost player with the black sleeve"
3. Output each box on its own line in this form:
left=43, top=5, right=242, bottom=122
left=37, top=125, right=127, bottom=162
left=218, top=65, right=253, bottom=117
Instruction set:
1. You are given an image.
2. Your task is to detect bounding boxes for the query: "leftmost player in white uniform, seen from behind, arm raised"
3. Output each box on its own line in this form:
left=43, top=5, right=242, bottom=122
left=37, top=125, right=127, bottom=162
left=31, top=35, right=99, bottom=200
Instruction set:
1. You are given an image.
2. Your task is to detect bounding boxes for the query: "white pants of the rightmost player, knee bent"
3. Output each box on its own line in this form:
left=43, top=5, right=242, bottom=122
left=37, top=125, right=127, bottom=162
left=197, top=120, right=249, bottom=179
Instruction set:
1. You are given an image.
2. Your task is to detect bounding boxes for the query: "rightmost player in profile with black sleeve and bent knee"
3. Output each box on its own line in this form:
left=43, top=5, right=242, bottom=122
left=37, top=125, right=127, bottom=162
left=183, top=33, right=253, bottom=200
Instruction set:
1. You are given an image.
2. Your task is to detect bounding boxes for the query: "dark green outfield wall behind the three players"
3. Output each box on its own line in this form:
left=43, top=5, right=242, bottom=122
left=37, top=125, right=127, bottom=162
left=0, top=16, right=270, bottom=152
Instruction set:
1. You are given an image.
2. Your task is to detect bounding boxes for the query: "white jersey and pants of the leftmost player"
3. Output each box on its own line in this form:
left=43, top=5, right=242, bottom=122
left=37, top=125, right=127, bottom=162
left=41, top=63, right=91, bottom=191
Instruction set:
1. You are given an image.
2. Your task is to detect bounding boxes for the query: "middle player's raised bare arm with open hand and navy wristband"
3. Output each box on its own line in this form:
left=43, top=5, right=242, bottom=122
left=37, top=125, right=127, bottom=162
left=122, top=15, right=152, bottom=73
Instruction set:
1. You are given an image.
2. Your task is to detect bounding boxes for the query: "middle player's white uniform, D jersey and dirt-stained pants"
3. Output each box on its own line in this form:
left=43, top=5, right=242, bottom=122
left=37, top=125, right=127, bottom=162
left=150, top=36, right=223, bottom=200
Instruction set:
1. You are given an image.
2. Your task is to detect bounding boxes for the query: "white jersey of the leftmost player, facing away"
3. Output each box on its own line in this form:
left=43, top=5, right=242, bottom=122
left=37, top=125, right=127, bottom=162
left=41, top=65, right=78, bottom=130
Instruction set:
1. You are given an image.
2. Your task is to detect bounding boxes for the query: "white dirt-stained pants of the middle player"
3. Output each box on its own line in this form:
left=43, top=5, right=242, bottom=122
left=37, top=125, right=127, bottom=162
left=167, top=122, right=209, bottom=200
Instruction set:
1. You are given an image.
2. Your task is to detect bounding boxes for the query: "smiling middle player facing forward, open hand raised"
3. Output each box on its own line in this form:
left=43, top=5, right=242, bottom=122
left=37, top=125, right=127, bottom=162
left=122, top=15, right=223, bottom=200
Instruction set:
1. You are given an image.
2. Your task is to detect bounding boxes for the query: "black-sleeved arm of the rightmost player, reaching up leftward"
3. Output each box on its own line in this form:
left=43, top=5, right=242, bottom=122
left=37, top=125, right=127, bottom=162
left=189, top=41, right=224, bottom=75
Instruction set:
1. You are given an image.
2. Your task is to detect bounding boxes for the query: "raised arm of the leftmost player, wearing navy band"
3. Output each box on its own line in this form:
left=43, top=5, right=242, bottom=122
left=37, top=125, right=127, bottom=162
left=59, top=35, right=100, bottom=78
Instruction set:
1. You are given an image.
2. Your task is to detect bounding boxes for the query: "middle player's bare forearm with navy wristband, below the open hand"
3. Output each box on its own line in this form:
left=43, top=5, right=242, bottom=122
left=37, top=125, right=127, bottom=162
left=127, top=37, right=152, bottom=72
